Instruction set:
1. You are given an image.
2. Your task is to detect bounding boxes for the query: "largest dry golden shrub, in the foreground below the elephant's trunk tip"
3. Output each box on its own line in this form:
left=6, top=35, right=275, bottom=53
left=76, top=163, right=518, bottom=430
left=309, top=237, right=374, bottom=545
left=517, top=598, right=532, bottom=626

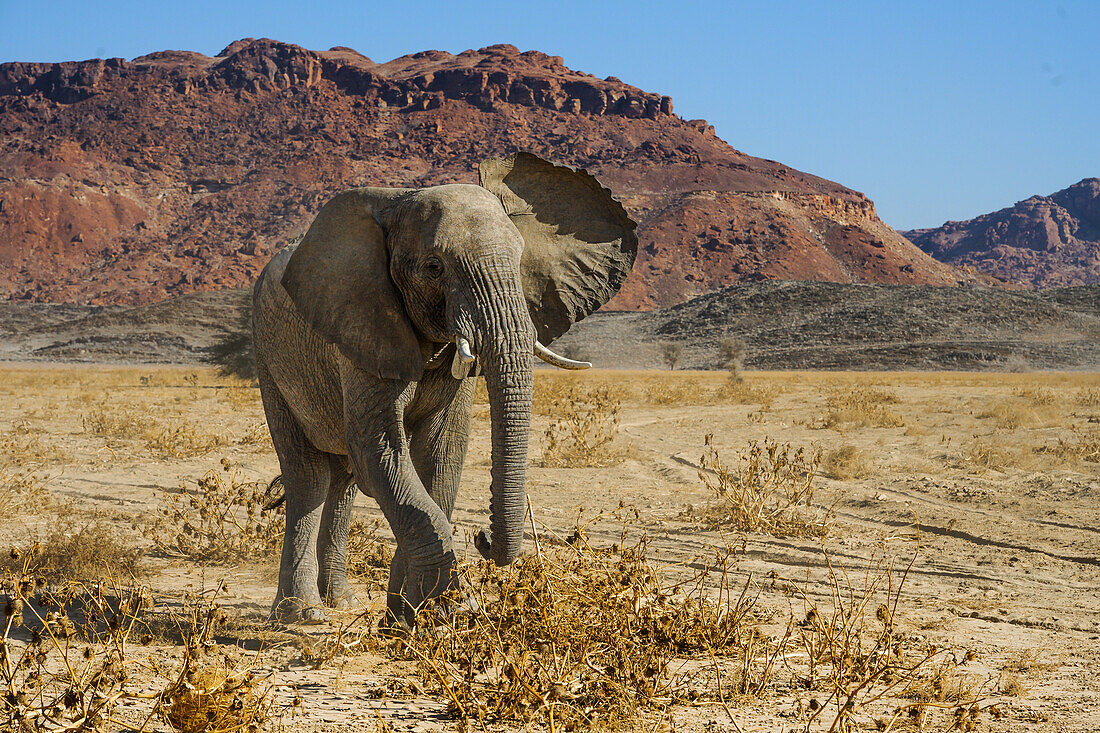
left=406, top=519, right=782, bottom=731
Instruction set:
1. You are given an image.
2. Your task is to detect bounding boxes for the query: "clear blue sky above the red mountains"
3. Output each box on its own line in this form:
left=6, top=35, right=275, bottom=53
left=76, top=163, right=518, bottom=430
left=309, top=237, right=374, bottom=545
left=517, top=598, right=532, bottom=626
left=0, top=0, right=1100, bottom=229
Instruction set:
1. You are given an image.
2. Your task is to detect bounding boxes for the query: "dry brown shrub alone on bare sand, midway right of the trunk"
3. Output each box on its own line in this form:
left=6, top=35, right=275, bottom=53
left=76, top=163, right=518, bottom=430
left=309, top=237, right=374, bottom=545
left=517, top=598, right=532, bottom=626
left=695, top=434, right=834, bottom=537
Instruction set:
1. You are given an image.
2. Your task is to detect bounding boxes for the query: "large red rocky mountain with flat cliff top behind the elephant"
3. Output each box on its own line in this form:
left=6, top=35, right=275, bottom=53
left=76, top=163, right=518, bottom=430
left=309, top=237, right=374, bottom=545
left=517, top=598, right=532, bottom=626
left=0, top=39, right=988, bottom=309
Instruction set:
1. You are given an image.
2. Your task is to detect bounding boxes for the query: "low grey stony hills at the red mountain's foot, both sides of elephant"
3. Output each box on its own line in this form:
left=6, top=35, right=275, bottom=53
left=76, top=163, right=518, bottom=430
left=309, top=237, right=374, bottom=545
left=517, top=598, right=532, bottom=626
left=0, top=282, right=1100, bottom=370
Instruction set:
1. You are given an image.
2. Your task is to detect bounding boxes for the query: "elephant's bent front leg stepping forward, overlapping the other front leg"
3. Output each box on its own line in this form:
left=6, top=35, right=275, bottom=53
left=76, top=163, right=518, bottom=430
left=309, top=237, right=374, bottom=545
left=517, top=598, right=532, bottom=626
left=344, top=368, right=454, bottom=621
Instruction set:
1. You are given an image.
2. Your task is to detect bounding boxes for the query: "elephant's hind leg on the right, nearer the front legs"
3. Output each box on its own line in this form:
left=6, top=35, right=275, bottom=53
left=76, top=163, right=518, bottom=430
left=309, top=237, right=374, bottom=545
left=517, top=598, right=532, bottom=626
left=317, top=455, right=359, bottom=609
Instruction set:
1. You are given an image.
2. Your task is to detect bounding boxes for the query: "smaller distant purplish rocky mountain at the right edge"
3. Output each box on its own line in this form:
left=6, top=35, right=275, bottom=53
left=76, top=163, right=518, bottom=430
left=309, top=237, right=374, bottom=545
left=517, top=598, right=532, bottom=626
left=905, top=178, right=1100, bottom=287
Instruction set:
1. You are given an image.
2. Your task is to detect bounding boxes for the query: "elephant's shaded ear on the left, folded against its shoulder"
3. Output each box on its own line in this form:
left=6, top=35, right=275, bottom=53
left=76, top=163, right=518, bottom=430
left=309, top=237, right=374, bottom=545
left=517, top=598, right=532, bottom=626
left=282, top=188, right=424, bottom=381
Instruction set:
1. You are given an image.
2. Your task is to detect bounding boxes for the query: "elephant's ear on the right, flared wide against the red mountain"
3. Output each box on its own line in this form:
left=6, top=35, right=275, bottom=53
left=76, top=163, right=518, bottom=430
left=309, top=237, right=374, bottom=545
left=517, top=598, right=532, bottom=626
left=477, top=153, right=638, bottom=343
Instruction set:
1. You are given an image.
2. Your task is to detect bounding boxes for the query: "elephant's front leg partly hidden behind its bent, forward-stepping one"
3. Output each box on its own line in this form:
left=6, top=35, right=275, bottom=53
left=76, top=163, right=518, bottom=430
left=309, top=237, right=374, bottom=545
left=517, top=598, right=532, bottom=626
left=386, top=369, right=477, bottom=623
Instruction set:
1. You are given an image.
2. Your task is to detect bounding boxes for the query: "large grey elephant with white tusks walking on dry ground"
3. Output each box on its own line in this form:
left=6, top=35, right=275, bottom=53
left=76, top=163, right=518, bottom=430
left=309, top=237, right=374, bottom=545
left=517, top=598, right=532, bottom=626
left=252, top=152, right=638, bottom=624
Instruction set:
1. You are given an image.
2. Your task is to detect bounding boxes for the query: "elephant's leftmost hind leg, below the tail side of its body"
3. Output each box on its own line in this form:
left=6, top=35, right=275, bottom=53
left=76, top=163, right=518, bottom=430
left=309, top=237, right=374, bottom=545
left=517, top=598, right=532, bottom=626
left=257, top=365, right=330, bottom=622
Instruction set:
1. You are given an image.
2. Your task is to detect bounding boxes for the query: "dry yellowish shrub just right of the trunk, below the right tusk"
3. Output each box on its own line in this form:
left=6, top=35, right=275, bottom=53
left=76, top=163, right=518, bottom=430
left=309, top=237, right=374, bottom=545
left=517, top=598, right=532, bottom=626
left=539, top=386, right=625, bottom=468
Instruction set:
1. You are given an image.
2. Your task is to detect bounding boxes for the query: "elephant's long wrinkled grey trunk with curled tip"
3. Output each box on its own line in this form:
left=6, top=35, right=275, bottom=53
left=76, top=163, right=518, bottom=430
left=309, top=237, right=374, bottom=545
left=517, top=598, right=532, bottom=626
left=479, top=299, right=535, bottom=566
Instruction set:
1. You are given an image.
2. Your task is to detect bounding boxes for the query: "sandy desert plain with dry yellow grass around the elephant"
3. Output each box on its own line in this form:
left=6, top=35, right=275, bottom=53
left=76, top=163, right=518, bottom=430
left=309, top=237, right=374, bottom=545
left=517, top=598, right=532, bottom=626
left=0, top=363, right=1100, bottom=733
